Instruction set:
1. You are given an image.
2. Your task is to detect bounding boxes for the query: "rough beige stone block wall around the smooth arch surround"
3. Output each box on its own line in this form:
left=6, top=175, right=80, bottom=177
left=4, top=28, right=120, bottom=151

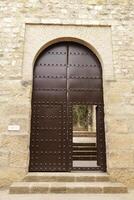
left=0, top=0, right=134, bottom=186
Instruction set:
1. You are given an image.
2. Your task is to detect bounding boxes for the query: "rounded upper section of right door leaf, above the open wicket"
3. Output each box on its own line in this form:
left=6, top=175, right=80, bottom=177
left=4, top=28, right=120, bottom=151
left=68, top=44, right=102, bottom=104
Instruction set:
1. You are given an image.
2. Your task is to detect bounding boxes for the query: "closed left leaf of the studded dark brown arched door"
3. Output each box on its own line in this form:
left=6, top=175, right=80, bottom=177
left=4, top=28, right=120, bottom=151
left=29, top=44, right=68, bottom=171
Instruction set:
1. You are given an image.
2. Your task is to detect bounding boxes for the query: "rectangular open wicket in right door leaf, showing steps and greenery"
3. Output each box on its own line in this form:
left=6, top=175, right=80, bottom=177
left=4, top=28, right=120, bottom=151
left=73, top=105, right=98, bottom=170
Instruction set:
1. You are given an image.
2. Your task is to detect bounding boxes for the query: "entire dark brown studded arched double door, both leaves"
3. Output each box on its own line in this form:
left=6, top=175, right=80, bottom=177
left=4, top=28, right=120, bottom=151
left=29, top=42, right=106, bottom=172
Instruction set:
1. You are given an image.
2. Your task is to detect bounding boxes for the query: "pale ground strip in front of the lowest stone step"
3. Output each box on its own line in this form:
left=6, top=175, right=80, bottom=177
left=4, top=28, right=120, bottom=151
left=0, top=190, right=134, bottom=200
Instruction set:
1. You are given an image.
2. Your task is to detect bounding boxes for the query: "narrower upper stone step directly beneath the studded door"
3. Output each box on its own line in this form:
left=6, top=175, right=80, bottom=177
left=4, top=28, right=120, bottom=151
left=23, top=172, right=109, bottom=182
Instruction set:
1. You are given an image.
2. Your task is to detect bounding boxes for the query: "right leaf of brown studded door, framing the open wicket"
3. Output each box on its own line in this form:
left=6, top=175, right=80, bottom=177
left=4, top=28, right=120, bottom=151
left=68, top=43, right=106, bottom=171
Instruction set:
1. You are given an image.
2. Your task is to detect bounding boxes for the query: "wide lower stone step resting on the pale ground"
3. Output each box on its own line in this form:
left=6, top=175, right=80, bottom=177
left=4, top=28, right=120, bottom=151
left=9, top=182, right=127, bottom=194
